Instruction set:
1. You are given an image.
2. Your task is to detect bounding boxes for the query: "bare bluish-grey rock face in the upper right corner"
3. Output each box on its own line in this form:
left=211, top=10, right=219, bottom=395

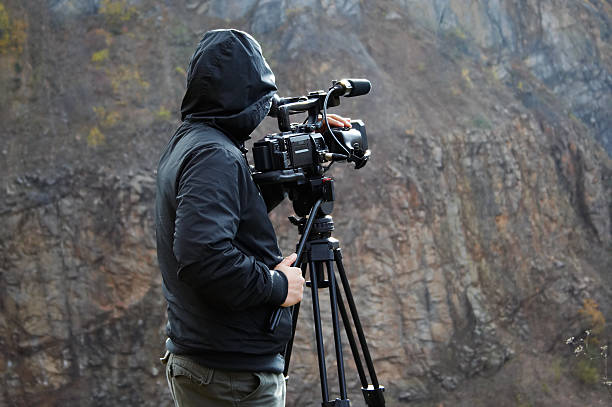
left=396, top=0, right=612, bottom=156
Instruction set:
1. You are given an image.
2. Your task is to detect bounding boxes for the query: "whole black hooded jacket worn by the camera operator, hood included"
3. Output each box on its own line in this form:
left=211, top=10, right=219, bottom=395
left=156, top=30, right=291, bottom=372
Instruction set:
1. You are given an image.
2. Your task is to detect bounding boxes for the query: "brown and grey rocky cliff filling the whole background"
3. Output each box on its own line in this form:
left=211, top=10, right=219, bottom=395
left=0, top=0, right=612, bottom=406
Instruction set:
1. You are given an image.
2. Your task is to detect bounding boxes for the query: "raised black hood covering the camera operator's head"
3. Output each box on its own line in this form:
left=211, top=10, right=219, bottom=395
left=181, top=30, right=276, bottom=142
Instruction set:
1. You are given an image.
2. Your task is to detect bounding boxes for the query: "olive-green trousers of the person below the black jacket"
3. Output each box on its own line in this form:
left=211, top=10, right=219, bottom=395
left=161, top=352, right=285, bottom=407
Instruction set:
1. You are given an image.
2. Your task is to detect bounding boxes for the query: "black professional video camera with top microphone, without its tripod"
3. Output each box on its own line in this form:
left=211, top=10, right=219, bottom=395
left=253, top=79, right=371, bottom=190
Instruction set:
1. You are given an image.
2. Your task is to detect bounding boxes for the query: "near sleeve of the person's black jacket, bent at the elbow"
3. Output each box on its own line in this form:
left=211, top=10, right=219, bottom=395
left=173, top=148, right=287, bottom=310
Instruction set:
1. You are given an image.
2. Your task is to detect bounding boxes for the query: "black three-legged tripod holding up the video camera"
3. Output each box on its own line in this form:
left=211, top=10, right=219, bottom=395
left=270, top=178, right=385, bottom=407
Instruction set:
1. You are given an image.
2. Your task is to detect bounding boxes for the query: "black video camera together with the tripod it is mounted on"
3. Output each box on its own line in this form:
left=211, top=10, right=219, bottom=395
left=253, top=79, right=385, bottom=407
